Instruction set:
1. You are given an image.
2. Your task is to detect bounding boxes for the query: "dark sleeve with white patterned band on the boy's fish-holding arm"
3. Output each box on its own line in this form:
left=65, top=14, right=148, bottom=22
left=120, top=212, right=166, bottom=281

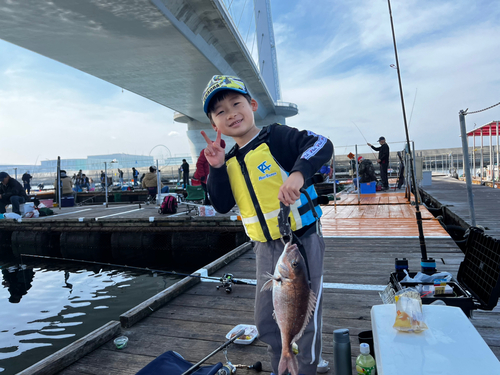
left=270, top=125, right=333, bottom=180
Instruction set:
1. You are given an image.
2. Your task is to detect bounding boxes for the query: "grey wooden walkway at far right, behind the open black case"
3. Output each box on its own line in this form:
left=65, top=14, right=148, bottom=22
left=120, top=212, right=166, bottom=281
left=421, top=176, right=500, bottom=238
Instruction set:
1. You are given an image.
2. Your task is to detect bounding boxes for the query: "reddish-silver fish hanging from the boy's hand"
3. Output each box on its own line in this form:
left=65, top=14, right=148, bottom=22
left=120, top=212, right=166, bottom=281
left=261, top=242, right=316, bottom=375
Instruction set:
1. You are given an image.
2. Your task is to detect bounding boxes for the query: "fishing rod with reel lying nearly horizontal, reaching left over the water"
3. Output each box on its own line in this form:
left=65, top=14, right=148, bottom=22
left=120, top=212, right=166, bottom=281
left=21, top=254, right=255, bottom=293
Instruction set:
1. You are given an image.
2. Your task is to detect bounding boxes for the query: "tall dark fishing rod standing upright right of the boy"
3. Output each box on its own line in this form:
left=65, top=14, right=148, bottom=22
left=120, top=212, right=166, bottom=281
left=387, top=0, right=430, bottom=273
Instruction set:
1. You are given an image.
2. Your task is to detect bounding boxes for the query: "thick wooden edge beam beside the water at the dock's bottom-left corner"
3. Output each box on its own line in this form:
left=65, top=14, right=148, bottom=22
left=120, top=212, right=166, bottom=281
left=18, top=320, right=120, bottom=375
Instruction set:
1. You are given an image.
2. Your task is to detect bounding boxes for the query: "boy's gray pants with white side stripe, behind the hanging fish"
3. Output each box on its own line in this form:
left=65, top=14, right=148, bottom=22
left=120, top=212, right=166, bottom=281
left=254, top=233, right=325, bottom=375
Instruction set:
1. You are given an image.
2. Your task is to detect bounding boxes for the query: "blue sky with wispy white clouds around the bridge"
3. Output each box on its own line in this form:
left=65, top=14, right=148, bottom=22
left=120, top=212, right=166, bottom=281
left=0, top=0, right=500, bottom=165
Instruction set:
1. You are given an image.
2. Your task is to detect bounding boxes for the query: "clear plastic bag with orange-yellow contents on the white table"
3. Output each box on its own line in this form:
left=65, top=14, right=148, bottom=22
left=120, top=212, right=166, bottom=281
left=393, top=288, right=428, bottom=333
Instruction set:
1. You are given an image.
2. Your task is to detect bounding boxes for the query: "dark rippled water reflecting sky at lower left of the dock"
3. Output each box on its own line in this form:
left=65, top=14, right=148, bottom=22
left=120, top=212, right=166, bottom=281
left=0, top=260, right=180, bottom=375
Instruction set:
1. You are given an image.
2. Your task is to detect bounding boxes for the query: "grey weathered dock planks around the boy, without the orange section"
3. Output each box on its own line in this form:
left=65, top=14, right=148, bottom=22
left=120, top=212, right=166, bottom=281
left=52, top=238, right=500, bottom=375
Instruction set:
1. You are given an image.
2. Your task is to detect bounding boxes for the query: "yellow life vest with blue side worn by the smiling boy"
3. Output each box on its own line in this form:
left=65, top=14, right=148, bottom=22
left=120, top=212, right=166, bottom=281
left=226, top=143, right=321, bottom=242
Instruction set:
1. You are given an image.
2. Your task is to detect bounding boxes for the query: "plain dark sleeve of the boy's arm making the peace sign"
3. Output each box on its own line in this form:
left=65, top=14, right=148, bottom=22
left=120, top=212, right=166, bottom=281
left=207, top=164, right=236, bottom=214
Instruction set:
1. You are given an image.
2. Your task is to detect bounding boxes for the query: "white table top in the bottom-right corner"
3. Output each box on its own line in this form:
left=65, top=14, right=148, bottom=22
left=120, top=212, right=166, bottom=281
left=371, top=304, right=500, bottom=375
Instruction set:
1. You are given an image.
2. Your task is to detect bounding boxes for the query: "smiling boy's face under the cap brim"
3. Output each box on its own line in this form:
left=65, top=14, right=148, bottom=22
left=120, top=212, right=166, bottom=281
left=211, top=92, right=258, bottom=142
